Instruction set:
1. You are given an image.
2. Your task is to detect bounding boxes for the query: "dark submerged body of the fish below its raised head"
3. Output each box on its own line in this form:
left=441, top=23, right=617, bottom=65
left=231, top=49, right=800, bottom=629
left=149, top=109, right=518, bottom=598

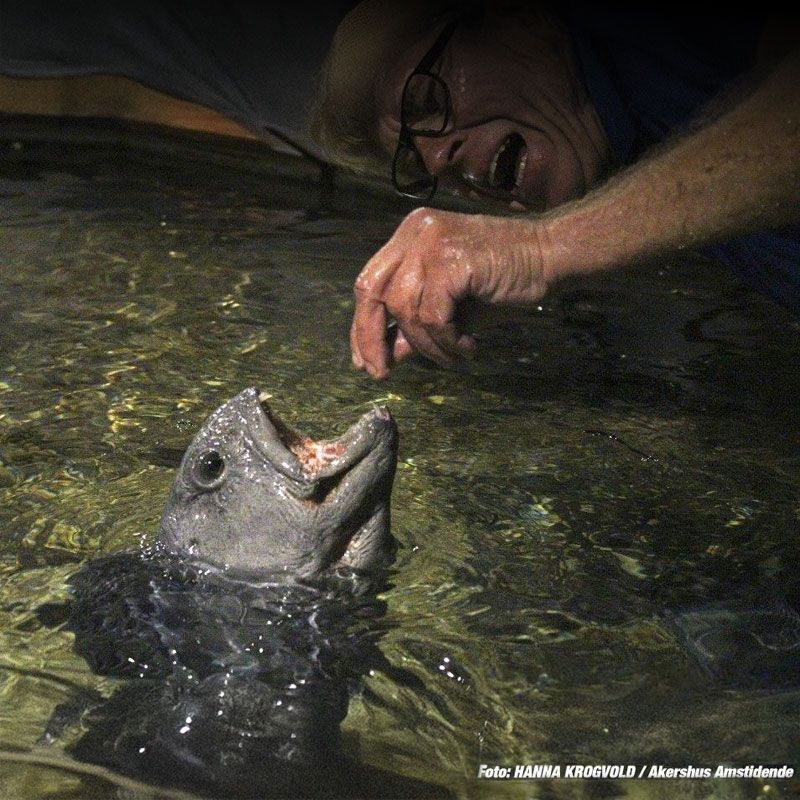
left=65, top=551, right=428, bottom=800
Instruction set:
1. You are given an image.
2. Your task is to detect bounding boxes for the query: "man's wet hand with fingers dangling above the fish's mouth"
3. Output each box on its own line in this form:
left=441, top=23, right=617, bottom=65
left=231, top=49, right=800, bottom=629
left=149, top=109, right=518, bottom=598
left=350, top=208, right=547, bottom=378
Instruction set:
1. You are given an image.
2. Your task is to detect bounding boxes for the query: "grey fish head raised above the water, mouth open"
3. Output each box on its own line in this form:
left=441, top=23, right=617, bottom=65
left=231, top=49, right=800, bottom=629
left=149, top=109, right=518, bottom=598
left=159, top=388, right=398, bottom=579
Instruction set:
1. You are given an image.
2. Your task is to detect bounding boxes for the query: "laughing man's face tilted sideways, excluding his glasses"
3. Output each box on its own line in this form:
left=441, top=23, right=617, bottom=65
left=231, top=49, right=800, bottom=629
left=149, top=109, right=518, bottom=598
left=375, top=8, right=610, bottom=211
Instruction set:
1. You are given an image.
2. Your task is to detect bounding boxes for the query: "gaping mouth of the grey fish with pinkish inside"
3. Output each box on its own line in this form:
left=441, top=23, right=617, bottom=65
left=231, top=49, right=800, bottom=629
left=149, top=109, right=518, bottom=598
left=255, top=392, right=397, bottom=503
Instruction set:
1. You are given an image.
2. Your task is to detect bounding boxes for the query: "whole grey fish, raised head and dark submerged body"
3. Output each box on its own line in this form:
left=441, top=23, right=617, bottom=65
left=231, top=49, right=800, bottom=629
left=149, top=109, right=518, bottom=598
left=42, top=388, right=447, bottom=798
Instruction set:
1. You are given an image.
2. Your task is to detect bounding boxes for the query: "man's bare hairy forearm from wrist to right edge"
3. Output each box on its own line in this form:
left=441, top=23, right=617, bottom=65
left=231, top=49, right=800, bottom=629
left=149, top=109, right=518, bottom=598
left=537, top=52, right=800, bottom=281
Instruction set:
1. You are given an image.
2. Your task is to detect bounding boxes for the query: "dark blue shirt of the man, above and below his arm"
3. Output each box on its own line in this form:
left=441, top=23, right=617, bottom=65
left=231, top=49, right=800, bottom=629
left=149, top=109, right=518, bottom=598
left=559, top=2, right=800, bottom=314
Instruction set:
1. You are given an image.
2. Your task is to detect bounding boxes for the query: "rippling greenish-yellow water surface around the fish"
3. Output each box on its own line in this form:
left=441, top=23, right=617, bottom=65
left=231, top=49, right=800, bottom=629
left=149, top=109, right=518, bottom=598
left=0, top=121, right=800, bottom=800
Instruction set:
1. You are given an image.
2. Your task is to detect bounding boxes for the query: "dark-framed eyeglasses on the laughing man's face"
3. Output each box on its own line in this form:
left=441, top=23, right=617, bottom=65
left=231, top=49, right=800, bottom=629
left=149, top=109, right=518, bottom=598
left=392, top=18, right=461, bottom=201
